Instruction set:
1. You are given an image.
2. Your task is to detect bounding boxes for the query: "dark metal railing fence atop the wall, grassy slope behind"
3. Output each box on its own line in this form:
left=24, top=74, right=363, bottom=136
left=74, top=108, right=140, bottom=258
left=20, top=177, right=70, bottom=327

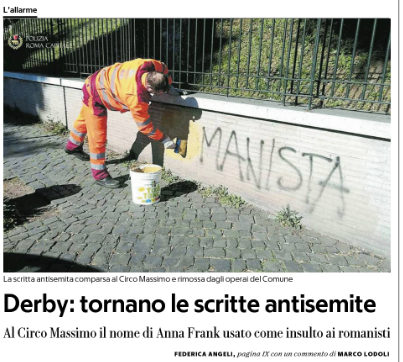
left=3, top=19, right=391, bottom=113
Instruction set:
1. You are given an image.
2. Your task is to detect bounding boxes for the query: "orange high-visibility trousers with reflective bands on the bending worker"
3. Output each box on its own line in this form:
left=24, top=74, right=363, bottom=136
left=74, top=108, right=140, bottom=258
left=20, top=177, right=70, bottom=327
left=67, top=73, right=109, bottom=180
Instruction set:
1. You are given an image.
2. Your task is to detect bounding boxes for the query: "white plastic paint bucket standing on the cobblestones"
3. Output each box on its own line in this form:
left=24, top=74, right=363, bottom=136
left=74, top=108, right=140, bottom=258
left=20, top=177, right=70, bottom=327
left=130, top=164, right=162, bottom=205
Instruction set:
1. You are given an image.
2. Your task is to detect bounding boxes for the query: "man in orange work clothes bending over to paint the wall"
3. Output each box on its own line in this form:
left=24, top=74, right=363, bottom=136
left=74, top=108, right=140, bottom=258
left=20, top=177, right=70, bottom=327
left=65, top=59, right=179, bottom=188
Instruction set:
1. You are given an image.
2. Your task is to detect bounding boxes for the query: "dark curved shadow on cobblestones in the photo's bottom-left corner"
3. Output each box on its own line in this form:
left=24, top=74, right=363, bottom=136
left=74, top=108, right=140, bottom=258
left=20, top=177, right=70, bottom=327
left=3, top=253, right=101, bottom=273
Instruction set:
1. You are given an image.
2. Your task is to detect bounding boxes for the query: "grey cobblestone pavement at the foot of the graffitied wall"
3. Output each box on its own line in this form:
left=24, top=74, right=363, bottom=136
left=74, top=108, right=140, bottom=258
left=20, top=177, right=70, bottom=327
left=3, top=120, right=390, bottom=272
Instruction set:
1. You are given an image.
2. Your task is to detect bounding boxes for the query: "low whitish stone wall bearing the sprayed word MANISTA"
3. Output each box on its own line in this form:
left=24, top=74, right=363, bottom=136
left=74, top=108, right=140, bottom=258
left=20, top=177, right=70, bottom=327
left=4, top=74, right=391, bottom=255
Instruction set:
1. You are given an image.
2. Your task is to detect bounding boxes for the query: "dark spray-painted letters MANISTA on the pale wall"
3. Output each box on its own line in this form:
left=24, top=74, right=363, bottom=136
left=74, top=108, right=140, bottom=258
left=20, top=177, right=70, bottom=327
left=200, top=127, right=350, bottom=218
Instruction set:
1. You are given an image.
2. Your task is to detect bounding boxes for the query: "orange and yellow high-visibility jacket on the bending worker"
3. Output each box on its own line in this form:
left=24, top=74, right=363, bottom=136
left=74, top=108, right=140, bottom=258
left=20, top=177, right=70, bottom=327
left=95, top=59, right=172, bottom=141
